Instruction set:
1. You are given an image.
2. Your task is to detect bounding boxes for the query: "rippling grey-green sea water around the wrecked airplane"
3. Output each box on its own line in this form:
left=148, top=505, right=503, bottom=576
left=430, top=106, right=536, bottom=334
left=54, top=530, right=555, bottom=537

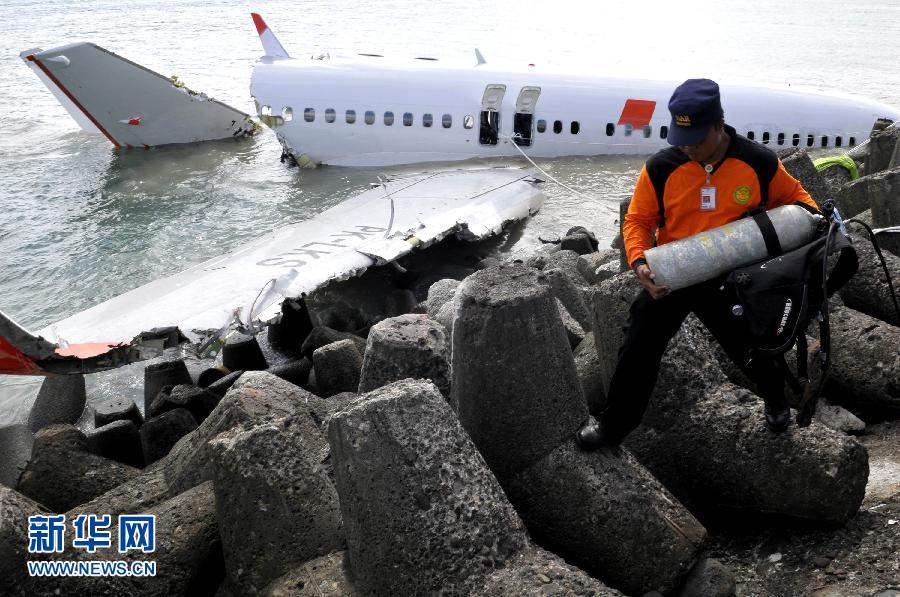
left=0, top=0, right=900, bottom=418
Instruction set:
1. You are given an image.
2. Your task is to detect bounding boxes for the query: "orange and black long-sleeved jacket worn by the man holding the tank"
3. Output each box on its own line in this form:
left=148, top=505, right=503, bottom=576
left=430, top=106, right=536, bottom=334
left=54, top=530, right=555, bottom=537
left=622, top=125, right=819, bottom=268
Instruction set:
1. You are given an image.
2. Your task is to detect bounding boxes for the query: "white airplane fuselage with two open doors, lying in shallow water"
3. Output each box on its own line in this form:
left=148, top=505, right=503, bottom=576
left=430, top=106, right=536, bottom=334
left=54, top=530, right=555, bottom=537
left=250, top=56, right=900, bottom=166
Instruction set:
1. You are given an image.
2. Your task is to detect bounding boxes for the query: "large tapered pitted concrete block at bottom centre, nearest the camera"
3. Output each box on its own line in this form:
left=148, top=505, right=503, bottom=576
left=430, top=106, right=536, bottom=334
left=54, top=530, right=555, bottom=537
left=328, top=380, right=528, bottom=595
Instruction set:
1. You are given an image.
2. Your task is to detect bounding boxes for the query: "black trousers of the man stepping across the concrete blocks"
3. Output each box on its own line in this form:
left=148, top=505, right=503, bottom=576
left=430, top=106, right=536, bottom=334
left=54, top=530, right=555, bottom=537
left=600, top=279, right=787, bottom=442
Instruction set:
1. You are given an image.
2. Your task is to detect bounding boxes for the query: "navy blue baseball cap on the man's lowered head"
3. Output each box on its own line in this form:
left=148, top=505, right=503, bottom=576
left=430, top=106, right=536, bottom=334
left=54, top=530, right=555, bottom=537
left=666, top=79, right=724, bottom=145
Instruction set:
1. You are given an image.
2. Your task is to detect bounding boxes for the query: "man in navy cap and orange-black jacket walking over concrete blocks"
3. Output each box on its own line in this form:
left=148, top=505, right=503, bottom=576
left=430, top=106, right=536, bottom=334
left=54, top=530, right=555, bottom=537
left=577, top=79, right=818, bottom=449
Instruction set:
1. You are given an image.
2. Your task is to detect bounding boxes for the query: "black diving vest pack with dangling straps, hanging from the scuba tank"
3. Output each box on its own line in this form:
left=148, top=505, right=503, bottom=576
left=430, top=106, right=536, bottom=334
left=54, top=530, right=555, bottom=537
left=725, top=203, right=859, bottom=426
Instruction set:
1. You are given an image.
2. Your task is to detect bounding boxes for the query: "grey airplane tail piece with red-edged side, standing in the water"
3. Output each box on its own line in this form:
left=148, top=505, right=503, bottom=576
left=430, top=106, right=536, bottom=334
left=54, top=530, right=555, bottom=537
left=19, top=43, right=257, bottom=148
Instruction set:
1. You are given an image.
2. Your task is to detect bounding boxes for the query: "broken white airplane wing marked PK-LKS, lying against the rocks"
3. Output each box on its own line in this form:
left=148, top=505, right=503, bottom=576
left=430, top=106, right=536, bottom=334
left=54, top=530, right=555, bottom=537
left=0, top=168, right=544, bottom=375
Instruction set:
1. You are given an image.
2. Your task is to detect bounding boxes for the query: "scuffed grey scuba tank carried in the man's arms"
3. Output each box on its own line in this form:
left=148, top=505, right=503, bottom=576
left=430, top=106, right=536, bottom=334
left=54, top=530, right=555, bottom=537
left=644, top=205, right=826, bottom=290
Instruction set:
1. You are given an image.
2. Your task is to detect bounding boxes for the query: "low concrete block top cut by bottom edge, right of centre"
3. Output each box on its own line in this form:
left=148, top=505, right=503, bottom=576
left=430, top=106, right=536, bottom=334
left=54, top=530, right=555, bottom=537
left=469, top=547, right=622, bottom=597
